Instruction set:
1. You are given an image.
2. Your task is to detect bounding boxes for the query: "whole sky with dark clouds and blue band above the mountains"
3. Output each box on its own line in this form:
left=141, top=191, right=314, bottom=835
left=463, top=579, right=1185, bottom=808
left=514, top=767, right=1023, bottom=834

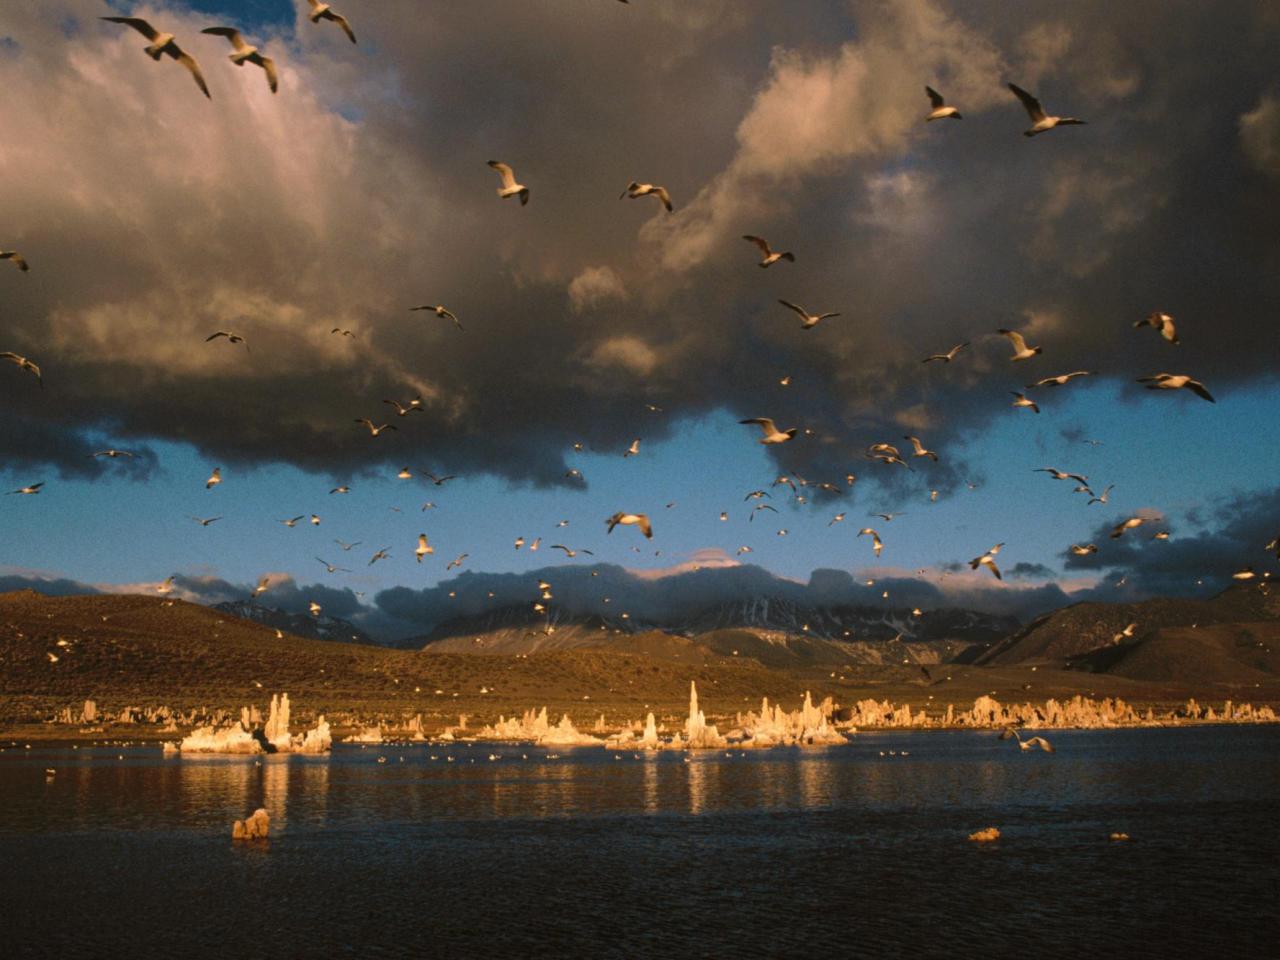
left=0, top=0, right=1280, bottom=636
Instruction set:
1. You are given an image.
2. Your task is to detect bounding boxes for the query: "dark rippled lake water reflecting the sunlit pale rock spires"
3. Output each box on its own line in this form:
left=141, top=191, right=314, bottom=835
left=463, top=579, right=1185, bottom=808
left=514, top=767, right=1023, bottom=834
left=0, top=727, right=1280, bottom=960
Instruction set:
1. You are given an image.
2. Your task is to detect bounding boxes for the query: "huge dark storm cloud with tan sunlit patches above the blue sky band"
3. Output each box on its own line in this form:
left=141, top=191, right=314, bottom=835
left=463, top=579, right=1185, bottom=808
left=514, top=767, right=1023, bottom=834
left=0, top=0, right=1280, bottom=500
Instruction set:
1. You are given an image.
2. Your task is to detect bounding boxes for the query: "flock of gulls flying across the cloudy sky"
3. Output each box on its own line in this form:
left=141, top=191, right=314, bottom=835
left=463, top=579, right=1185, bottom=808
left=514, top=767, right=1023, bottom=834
left=0, top=0, right=1280, bottom=640
